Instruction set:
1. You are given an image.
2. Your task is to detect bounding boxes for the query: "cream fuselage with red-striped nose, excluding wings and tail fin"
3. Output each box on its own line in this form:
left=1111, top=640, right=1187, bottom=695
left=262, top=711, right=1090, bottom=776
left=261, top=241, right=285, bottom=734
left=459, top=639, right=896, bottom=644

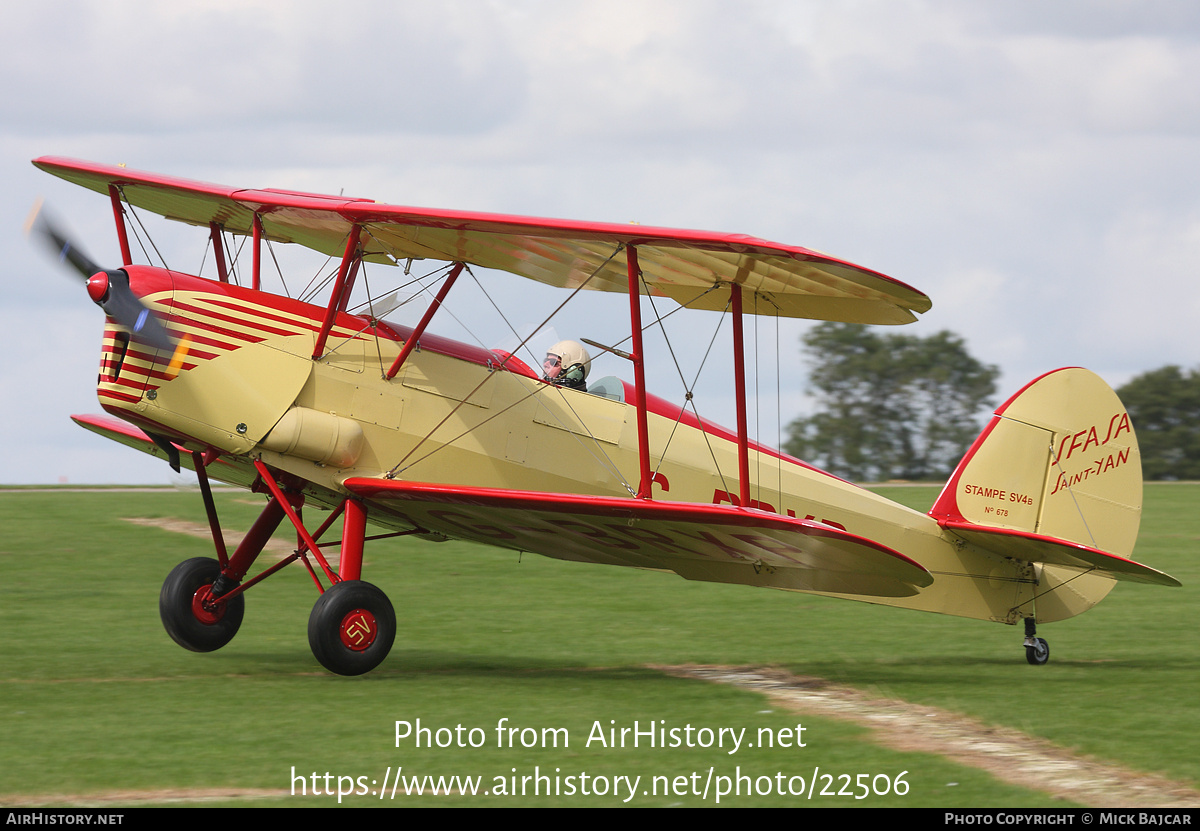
left=97, top=267, right=1104, bottom=622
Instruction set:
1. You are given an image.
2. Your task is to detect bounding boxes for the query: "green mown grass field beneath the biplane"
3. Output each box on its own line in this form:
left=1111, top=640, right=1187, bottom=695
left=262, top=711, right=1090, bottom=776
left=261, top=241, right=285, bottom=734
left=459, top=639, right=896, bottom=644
left=0, top=484, right=1200, bottom=808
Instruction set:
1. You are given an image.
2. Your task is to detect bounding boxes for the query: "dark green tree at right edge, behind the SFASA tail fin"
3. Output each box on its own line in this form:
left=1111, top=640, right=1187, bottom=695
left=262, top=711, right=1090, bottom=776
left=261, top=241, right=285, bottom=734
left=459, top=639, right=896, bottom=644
left=1117, top=366, right=1200, bottom=479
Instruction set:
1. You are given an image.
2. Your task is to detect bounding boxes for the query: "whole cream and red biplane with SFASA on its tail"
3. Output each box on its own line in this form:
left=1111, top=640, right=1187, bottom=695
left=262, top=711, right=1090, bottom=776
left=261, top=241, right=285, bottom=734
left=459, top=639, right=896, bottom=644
left=32, top=157, right=1180, bottom=675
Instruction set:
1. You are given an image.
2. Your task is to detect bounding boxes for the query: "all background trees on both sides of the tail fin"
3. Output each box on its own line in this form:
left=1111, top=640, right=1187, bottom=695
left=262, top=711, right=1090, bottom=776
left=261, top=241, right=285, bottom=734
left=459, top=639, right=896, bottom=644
left=784, top=323, right=1200, bottom=482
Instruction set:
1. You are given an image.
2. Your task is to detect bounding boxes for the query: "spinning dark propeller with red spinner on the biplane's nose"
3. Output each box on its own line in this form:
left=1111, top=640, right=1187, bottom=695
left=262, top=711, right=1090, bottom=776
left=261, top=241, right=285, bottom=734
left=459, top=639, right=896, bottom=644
left=26, top=203, right=177, bottom=357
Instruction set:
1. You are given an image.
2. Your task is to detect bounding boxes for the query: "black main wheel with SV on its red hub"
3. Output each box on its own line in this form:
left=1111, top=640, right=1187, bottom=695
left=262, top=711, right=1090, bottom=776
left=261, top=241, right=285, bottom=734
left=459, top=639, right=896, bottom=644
left=308, top=580, right=396, bottom=675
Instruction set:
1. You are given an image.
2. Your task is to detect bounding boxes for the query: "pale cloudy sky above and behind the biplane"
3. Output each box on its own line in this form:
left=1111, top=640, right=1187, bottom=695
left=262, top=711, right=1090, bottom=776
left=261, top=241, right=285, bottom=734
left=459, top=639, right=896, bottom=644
left=0, top=0, right=1200, bottom=484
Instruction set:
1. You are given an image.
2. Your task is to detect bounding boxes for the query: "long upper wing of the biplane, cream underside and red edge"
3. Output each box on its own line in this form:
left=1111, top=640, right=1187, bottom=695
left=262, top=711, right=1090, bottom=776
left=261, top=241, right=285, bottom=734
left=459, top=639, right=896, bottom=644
left=34, top=156, right=931, bottom=323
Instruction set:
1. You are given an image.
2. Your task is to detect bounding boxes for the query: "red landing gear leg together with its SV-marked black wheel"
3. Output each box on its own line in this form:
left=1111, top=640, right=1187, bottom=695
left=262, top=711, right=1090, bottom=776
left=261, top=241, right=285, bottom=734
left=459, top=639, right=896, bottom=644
left=308, top=500, right=396, bottom=675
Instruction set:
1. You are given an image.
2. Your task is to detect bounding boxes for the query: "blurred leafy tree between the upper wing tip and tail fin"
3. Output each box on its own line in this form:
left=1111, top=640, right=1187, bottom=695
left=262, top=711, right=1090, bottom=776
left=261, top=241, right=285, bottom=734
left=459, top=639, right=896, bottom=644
left=785, top=323, right=1000, bottom=482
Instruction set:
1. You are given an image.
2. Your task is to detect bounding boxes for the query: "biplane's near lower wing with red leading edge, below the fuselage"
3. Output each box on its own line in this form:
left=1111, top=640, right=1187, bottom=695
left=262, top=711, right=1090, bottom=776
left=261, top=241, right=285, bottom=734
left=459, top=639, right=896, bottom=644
left=343, top=478, right=934, bottom=597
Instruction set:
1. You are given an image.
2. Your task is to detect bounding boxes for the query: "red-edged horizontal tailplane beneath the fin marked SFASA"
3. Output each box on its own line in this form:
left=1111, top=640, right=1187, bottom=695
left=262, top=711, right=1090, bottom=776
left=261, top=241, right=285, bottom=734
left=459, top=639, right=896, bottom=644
left=941, top=521, right=1182, bottom=586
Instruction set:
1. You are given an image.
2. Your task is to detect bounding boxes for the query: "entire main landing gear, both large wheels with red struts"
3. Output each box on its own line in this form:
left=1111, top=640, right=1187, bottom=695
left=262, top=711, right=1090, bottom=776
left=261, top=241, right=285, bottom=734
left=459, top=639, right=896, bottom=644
left=158, top=453, right=396, bottom=675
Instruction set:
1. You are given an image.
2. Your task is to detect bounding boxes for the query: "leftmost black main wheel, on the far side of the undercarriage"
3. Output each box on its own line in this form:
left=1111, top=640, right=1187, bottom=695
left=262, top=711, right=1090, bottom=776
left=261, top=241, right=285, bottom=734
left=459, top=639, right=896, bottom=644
left=158, top=557, right=246, bottom=652
